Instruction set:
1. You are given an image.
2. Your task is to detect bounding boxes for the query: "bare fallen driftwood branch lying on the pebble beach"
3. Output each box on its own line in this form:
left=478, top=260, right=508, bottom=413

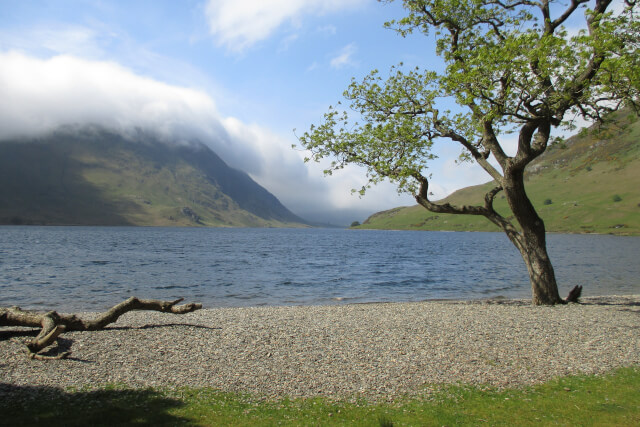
left=0, top=297, right=202, bottom=360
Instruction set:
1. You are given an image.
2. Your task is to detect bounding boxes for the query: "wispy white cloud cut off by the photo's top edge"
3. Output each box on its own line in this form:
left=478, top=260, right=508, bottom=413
left=205, top=0, right=369, bottom=52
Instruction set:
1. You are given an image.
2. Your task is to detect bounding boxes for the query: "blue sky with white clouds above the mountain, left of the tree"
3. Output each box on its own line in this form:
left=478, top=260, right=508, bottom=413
left=0, top=0, right=498, bottom=225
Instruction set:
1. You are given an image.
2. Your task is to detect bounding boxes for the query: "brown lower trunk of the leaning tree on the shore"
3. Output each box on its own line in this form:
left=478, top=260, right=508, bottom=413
left=504, top=170, right=565, bottom=305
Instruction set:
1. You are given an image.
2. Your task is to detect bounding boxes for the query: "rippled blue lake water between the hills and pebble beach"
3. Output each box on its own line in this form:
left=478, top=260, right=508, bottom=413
left=0, top=226, right=640, bottom=311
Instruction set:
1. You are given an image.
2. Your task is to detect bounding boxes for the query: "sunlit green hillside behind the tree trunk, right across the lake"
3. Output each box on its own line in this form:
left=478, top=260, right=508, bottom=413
left=357, top=109, right=640, bottom=235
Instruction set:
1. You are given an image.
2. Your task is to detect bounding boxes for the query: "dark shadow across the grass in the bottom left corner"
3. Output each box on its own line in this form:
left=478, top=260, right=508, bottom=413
left=0, top=383, right=189, bottom=426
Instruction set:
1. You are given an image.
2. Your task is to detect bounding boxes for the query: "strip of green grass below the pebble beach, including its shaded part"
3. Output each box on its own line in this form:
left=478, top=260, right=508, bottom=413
left=0, top=367, right=640, bottom=426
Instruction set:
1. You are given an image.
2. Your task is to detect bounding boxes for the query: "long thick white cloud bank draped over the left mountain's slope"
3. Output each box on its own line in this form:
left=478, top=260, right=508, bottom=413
left=0, top=52, right=411, bottom=224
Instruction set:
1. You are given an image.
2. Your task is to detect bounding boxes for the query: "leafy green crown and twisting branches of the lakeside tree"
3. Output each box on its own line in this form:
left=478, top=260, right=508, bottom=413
left=299, top=0, right=640, bottom=303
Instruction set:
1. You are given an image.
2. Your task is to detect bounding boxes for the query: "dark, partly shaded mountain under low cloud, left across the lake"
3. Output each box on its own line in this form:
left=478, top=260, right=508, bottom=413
left=0, top=126, right=305, bottom=227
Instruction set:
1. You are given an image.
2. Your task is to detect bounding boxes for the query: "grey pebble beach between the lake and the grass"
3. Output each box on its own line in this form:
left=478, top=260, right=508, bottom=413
left=0, top=295, right=640, bottom=400
